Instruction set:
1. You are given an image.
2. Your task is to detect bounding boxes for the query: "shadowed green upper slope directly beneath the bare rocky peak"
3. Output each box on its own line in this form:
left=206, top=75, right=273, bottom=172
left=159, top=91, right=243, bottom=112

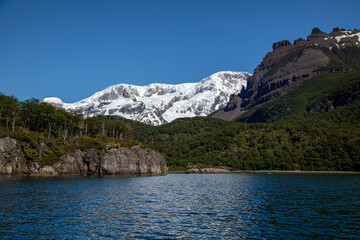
left=234, top=71, right=360, bottom=123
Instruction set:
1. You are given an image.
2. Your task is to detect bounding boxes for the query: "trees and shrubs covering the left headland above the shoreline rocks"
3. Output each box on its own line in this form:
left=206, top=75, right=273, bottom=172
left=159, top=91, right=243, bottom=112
left=0, top=94, right=137, bottom=166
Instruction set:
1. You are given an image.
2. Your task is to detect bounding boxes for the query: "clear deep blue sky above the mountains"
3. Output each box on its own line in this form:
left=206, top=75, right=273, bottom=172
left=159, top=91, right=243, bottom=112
left=0, top=0, right=360, bottom=102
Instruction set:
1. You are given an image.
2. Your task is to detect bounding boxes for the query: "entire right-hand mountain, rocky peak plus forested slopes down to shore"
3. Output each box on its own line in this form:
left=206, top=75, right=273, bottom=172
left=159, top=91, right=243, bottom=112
left=128, top=29, right=360, bottom=171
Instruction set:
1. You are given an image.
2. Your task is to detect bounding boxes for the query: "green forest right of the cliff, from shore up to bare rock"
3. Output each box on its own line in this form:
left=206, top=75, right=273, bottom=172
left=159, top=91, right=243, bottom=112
left=134, top=72, right=360, bottom=171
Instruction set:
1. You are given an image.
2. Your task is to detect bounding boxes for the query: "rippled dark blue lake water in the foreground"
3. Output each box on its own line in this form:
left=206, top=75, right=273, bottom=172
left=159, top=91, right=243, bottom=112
left=0, top=174, right=360, bottom=239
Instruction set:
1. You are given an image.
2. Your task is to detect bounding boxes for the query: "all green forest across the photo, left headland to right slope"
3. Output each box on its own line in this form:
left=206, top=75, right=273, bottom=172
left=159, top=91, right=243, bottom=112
left=0, top=71, right=360, bottom=171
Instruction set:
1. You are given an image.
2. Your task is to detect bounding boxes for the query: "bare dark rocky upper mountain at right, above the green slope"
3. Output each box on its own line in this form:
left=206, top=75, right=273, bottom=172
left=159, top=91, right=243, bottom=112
left=213, top=28, right=360, bottom=120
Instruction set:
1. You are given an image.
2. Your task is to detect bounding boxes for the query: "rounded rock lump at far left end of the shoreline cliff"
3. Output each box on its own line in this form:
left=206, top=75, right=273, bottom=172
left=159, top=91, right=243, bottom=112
left=0, top=137, right=29, bottom=174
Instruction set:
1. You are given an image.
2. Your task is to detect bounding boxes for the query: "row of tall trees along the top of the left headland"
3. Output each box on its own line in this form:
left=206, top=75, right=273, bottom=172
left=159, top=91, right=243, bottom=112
left=0, top=93, right=127, bottom=141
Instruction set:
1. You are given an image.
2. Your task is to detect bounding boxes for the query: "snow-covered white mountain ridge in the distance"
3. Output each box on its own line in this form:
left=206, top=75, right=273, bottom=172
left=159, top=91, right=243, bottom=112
left=43, top=71, right=251, bottom=125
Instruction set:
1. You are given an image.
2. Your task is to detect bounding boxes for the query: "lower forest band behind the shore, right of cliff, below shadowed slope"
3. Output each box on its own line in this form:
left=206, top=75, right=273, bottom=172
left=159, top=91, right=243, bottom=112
left=134, top=102, right=360, bottom=171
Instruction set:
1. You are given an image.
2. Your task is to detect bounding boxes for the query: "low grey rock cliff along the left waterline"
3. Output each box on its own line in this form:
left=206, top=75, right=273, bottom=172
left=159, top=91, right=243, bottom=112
left=0, top=137, right=168, bottom=176
